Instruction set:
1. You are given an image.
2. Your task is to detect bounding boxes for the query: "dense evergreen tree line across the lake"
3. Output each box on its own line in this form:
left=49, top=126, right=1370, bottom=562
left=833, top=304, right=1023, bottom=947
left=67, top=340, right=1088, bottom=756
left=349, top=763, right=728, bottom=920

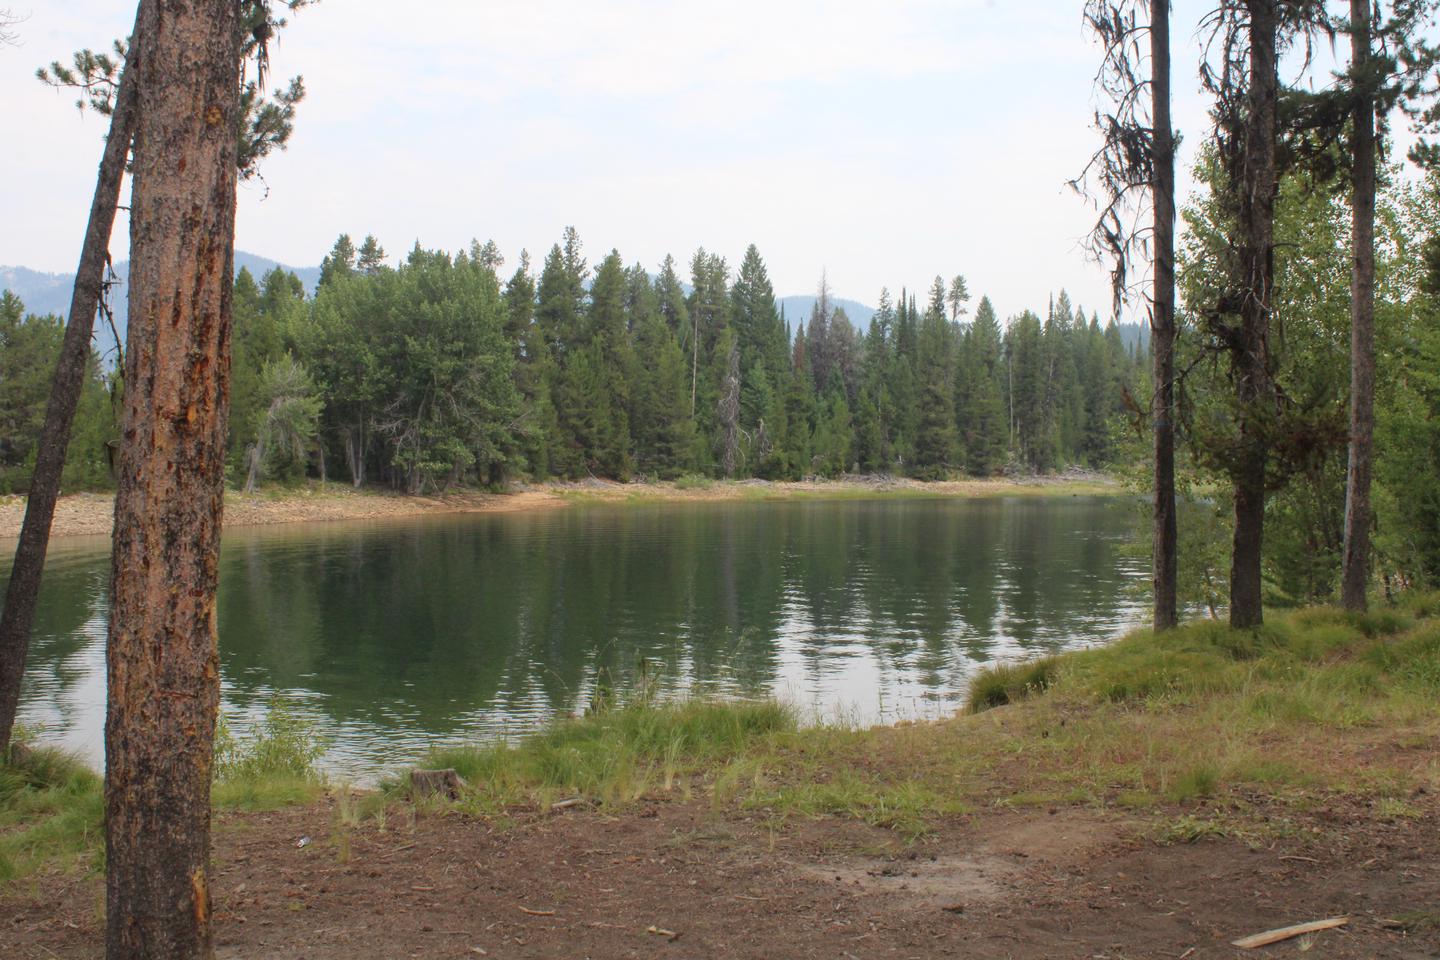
left=0, top=230, right=1145, bottom=494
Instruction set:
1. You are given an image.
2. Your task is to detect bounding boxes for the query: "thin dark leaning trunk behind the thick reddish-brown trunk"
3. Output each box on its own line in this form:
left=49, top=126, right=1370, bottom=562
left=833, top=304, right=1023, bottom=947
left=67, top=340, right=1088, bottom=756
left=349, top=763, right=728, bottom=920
left=0, top=4, right=144, bottom=754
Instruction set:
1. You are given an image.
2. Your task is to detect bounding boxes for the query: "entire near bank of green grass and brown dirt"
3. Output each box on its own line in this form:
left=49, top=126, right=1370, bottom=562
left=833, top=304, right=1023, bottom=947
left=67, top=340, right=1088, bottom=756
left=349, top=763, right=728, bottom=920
left=0, top=593, right=1440, bottom=960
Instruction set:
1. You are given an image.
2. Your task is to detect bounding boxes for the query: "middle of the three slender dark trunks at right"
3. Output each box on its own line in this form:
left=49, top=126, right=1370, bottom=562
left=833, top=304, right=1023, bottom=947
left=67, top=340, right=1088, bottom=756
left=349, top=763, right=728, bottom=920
left=1230, top=0, right=1280, bottom=629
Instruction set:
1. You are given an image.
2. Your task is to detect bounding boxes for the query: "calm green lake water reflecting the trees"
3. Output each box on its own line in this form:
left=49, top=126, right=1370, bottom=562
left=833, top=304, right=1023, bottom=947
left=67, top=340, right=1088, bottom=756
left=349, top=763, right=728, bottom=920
left=3, top=498, right=1145, bottom=777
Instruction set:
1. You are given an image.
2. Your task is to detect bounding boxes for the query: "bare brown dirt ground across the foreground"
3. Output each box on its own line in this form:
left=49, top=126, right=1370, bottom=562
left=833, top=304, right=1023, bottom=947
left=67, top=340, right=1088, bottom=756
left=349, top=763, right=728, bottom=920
left=0, top=797, right=1440, bottom=960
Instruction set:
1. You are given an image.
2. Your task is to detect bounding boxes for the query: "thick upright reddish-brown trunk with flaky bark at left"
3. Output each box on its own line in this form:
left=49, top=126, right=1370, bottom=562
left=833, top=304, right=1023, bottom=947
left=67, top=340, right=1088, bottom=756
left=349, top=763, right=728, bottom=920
left=105, top=0, right=240, bottom=960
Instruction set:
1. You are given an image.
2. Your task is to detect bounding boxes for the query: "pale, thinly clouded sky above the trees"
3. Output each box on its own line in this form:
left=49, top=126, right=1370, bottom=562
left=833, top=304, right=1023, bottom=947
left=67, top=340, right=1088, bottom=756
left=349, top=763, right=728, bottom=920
left=0, top=0, right=1336, bottom=325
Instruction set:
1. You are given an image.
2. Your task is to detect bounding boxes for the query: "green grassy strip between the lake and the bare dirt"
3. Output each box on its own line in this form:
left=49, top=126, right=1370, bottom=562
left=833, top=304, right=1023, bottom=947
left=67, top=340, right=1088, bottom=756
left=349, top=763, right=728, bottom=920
left=0, top=594, right=1440, bottom=878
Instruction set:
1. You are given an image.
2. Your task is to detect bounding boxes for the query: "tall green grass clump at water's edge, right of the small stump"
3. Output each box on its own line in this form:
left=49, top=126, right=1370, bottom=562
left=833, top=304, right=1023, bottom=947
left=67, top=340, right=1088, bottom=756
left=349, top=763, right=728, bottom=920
left=408, top=697, right=798, bottom=809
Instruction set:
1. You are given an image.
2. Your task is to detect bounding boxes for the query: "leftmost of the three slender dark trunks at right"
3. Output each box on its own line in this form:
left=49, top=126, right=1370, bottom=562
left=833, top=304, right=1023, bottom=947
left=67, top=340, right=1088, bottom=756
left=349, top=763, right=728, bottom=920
left=1151, top=0, right=1179, bottom=632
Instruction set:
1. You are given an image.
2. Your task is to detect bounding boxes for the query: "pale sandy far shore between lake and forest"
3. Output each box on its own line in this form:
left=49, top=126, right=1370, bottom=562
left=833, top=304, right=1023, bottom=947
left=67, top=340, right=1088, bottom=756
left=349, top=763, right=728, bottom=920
left=0, top=474, right=1125, bottom=540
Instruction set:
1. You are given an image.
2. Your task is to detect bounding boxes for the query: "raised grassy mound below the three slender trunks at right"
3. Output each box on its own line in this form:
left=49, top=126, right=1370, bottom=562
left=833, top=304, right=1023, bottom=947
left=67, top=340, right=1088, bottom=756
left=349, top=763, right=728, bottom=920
left=971, top=596, right=1440, bottom=819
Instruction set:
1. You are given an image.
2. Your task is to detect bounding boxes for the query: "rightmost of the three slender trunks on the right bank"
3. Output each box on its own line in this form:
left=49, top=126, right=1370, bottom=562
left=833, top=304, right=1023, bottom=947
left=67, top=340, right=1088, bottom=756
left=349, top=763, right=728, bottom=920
left=1341, top=0, right=1375, bottom=610
